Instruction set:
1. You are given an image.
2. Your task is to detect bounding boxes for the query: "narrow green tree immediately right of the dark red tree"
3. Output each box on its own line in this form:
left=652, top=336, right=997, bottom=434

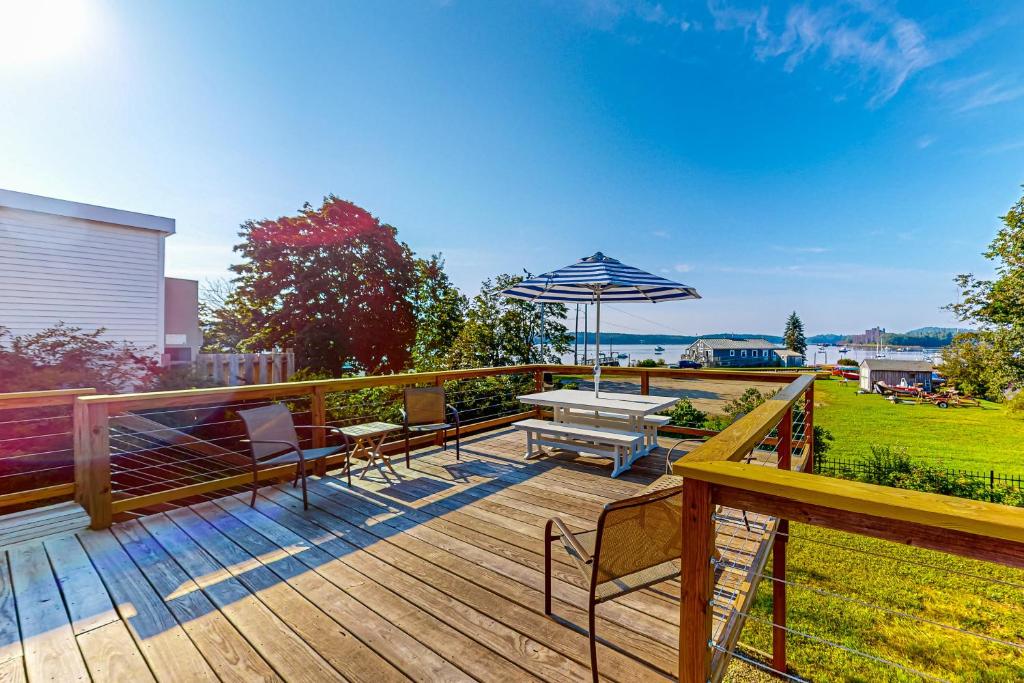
left=413, top=254, right=469, bottom=371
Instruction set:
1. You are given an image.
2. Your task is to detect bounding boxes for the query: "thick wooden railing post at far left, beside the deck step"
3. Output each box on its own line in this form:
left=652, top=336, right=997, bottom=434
left=73, top=399, right=112, bottom=528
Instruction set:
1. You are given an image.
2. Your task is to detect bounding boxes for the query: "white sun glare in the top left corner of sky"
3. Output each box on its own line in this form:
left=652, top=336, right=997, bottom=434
left=0, top=0, right=95, bottom=69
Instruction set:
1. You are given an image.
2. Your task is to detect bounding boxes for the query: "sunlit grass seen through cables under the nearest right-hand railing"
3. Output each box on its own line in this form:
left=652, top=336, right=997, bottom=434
left=741, top=524, right=1024, bottom=681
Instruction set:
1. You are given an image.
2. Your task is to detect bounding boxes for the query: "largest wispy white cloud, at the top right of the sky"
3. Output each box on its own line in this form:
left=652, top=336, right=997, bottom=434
left=708, top=0, right=950, bottom=106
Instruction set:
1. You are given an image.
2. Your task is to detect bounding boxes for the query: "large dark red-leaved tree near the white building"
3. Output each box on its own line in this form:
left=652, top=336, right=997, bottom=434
left=231, top=196, right=416, bottom=375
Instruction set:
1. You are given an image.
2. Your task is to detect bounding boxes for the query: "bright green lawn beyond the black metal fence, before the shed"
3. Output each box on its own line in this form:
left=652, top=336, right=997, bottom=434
left=814, top=380, right=1024, bottom=475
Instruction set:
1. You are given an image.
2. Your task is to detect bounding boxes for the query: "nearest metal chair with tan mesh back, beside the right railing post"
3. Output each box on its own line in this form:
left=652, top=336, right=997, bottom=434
left=544, top=486, right=683, bottom=683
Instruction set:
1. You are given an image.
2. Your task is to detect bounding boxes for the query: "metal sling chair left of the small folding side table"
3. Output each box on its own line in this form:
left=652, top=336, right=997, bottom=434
left=239, top=403, right=352, bottom=510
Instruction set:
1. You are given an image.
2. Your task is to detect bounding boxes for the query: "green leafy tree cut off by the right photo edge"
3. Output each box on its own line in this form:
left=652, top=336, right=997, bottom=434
left=940, top=187, right=1024, bottom=400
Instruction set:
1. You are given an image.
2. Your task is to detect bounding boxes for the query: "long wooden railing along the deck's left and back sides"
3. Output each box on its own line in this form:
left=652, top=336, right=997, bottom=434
left=0, top=365, right=799, bottom=528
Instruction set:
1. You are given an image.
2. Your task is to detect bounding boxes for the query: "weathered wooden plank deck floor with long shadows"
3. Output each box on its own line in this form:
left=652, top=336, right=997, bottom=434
left=0, top=429, right=767, bottom=683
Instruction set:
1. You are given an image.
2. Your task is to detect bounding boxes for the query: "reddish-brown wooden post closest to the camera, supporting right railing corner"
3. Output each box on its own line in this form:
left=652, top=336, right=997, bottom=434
left=679, top=478, right=715, bottom=683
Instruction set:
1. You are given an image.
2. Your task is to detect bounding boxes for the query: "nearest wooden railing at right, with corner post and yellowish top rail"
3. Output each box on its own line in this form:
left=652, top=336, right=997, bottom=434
left=673, top=376, right=1024, bottom=683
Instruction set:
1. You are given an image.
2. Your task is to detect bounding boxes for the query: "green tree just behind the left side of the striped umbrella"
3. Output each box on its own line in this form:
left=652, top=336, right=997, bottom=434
left=450, top=274, right=572, bottom=368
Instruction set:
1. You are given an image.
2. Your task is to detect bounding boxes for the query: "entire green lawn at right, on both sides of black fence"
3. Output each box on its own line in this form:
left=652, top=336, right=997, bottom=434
left=736, top=380, right=1024, bottom=681
